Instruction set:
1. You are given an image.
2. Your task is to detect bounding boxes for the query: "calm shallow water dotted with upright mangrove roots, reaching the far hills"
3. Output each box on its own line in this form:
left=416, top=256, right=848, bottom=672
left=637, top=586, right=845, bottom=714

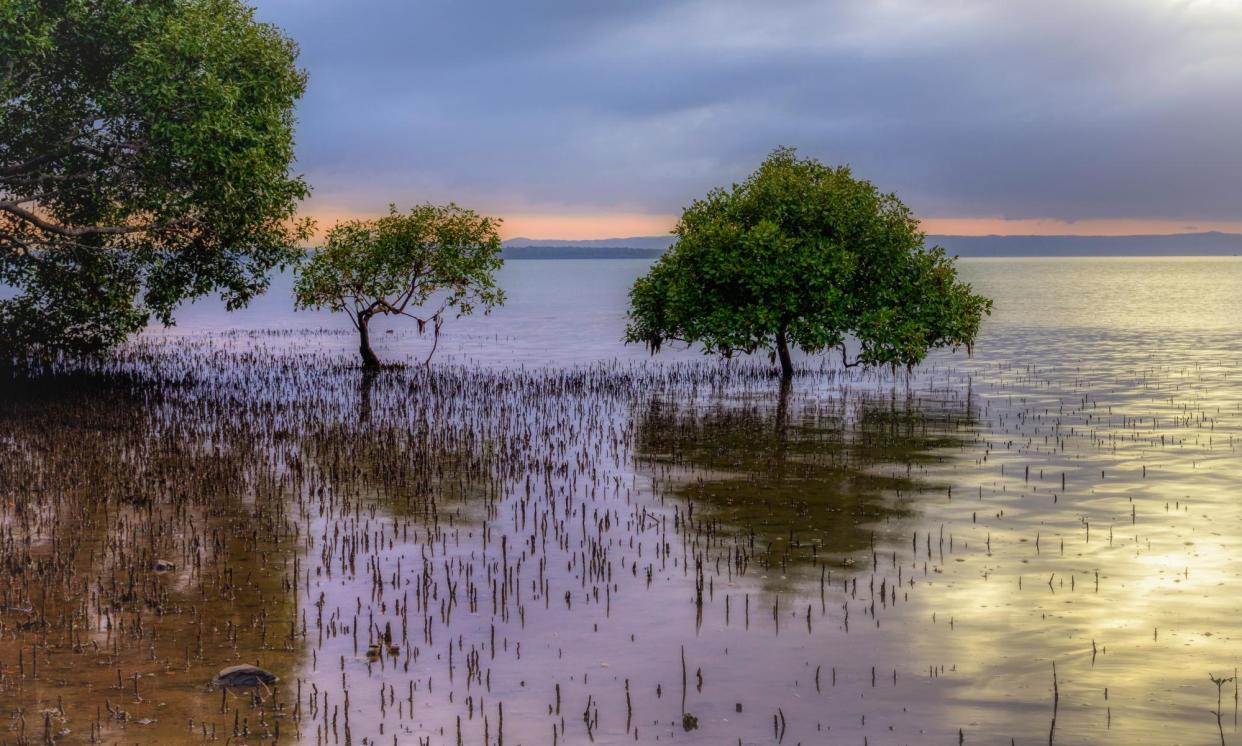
left=0, top=258, right=1242, bottom=744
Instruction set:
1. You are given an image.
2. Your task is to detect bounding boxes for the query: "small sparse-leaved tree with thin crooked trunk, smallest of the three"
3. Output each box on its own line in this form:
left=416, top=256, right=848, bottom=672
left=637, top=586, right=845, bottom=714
left=293, top=204, right=504, bottom=367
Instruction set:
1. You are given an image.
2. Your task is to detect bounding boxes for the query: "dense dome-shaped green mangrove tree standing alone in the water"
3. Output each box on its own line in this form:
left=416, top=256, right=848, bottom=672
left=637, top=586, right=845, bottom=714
left=626, top=149, right=991, bottom=374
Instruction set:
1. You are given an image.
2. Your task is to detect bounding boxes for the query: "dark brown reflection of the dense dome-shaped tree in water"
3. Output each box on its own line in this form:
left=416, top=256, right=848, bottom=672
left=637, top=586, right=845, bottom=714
left=637, top=386, right=972, bottom=566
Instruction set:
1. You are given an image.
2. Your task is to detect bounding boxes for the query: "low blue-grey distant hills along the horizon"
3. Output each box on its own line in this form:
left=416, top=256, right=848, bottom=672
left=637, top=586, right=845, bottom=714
left=504, top=231, right=1242, bottom=259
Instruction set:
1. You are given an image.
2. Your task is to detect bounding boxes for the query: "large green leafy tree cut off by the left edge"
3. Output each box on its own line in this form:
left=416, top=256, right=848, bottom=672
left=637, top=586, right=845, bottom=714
left=0, top=0, right=309, bottom=353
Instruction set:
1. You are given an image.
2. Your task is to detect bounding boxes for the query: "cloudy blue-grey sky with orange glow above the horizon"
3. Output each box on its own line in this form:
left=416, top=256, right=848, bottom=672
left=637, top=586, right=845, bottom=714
left=253, top=0, right=1242, bottom=238
